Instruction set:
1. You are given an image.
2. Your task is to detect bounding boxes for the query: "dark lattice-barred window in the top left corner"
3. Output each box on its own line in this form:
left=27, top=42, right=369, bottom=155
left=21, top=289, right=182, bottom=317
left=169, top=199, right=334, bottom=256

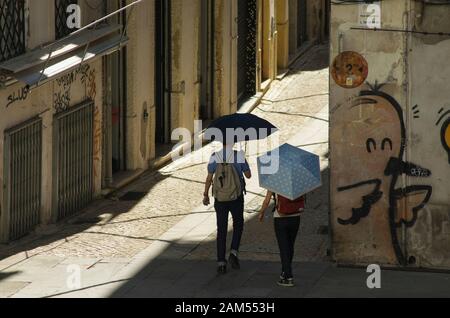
left=0, top=0, right=25, bottom=62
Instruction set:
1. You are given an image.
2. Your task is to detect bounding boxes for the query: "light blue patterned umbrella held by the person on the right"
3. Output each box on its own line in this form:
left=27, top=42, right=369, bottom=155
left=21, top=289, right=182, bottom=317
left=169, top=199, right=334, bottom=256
left=258, top=144, right=322, bottom=200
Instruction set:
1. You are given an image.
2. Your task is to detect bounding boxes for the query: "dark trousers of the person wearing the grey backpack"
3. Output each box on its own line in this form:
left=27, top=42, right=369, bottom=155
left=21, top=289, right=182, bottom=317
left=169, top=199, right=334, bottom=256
left=214, top=196, right=244, bottom=264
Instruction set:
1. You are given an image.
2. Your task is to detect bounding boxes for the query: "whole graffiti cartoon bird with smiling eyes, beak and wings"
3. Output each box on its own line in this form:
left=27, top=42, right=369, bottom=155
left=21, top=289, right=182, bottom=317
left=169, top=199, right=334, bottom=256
left=330, top=92, right=431, bottom=263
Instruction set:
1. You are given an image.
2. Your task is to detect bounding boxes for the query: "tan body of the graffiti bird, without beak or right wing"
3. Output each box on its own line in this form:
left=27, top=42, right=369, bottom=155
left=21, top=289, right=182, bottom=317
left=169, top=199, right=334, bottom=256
left=330, top=95, right=402, bottom=263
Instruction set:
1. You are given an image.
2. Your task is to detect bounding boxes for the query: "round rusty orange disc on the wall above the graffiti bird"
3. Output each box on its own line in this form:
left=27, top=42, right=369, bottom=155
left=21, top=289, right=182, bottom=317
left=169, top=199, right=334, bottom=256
left=331, top=51, right=369, bottom=89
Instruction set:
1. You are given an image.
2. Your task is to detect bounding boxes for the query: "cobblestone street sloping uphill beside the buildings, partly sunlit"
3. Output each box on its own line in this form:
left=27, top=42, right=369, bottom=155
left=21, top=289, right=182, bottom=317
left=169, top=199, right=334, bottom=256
left=0, top=45, right=329, bottom=296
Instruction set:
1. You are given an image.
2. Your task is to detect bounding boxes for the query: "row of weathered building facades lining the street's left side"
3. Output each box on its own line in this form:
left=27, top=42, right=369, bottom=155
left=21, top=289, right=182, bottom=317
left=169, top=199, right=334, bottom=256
left=0, top=0, right=327, bottom=242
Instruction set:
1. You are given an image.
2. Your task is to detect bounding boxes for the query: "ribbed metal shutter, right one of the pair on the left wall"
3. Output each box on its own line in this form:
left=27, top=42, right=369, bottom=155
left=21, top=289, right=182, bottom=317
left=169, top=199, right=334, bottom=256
left=53, top=101, right=94, bottom=220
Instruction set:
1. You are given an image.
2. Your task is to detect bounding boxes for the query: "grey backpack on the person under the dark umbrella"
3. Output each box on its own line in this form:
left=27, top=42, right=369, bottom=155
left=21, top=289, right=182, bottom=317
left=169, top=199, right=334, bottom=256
left=213, top=154, right=242, bottom=202
